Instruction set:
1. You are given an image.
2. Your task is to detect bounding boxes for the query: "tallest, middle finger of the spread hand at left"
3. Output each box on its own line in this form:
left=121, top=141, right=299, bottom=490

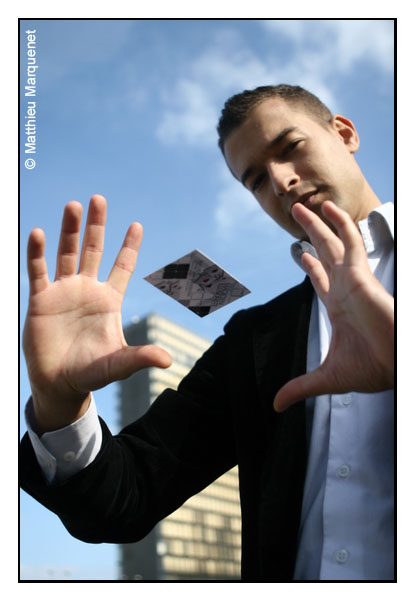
left=79, top=194, right=107, bottom=277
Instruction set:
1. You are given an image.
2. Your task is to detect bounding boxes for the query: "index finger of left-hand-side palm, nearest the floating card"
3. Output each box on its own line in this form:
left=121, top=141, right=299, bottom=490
left=108, top=223, right=143, bottom=295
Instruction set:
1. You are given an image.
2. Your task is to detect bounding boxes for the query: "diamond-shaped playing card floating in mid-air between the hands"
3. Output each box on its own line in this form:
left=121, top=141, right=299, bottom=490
left=144, top=250, right=250, bottom=317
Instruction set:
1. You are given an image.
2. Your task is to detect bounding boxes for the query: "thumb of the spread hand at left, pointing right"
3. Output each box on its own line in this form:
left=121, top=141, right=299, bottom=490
left=108, top=344, right=172, bottom=382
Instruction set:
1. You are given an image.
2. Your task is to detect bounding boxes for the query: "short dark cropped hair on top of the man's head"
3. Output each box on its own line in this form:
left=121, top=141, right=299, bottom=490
left=217, top=84, right=333, bottom=153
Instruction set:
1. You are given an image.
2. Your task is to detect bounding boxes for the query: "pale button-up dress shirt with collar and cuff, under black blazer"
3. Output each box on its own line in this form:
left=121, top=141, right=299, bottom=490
left=26, top=203, right=395, bottom=580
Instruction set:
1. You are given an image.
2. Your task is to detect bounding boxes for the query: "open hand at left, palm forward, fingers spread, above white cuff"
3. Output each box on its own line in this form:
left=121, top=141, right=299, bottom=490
left=23, top=195, right=171, bottom=433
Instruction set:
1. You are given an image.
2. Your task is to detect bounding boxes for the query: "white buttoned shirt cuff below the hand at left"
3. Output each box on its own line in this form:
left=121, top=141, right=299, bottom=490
left=25, top=395, right=102, bottom=484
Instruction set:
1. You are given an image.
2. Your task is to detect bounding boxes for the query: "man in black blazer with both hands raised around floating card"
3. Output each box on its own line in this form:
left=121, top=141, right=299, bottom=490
left=21, top=85, right=394, bottom=581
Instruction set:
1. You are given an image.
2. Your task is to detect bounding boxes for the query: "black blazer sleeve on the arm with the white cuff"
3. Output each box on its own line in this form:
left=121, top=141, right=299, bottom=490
left=19, top=322, right=237, bottom=543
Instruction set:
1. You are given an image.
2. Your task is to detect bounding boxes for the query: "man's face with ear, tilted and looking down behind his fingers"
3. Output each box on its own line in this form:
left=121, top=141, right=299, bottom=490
left=224, top=98, right=373, bottom=238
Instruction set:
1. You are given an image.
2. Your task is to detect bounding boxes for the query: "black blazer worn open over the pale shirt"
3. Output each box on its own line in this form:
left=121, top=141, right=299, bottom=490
left=20, top=278, right=313, bottom=582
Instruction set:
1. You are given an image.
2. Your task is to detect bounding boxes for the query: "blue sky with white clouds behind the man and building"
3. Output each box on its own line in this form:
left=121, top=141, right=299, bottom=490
left=20, top=20, right=394, bottom=579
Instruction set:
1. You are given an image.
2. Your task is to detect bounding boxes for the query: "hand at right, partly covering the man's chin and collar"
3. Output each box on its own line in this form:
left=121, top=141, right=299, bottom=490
left=274, top=201, right=394, bottom=411
